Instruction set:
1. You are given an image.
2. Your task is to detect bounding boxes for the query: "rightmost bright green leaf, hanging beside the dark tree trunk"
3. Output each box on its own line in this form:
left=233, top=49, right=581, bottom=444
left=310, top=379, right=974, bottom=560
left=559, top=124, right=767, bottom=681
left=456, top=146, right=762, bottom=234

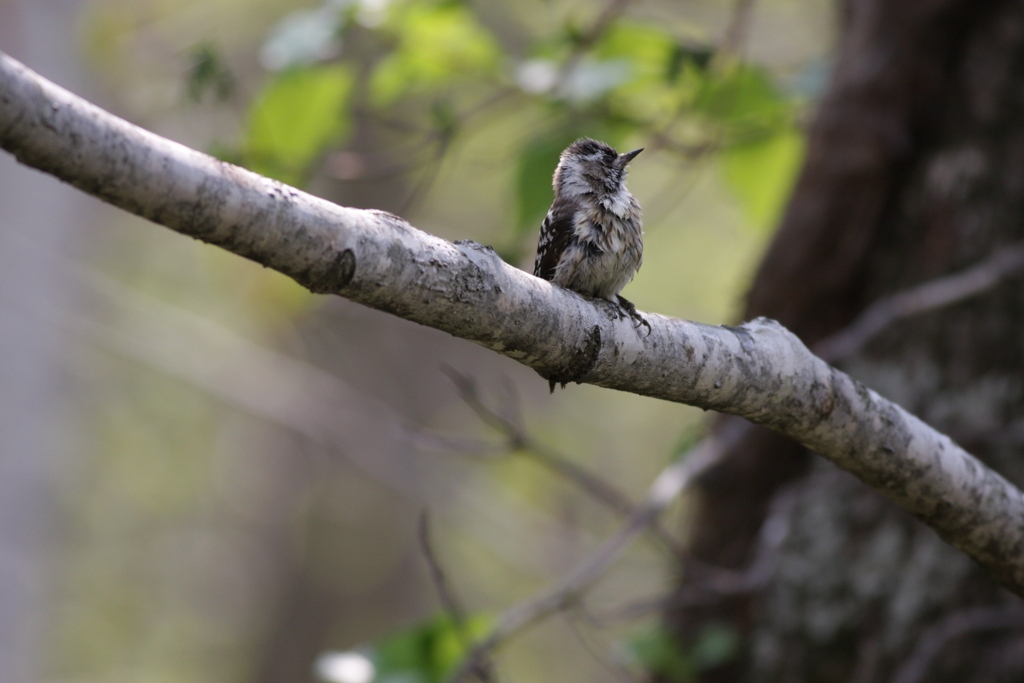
left=722, top=128, right=805, bottom=230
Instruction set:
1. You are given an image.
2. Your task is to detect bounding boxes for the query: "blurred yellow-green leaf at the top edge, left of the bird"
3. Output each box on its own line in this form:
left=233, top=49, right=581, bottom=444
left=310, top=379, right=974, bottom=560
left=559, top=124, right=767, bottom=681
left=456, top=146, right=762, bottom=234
left=370, top=3, right=501, bottom=106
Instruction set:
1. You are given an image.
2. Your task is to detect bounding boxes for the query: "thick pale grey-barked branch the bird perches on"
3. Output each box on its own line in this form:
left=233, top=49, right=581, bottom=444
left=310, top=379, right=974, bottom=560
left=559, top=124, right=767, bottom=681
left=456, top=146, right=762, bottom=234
left=0, top=54, right=1024, bottom=595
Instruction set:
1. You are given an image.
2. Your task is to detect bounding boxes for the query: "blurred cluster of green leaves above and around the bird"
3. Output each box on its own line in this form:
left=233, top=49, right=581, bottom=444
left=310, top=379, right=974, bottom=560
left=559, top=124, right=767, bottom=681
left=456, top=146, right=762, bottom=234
left=230, top=0, right=804, bottom=241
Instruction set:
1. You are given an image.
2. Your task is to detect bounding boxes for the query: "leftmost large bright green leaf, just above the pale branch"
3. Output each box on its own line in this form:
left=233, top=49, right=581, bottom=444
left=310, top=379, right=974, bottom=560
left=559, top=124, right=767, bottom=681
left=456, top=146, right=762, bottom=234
left=243, top=65, right=353, bottom=183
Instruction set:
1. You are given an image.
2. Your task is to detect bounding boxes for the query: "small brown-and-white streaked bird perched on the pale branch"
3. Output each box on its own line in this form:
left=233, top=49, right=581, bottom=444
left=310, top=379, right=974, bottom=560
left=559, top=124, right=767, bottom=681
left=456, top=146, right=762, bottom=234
left=534, top=137, right=650, bottom=391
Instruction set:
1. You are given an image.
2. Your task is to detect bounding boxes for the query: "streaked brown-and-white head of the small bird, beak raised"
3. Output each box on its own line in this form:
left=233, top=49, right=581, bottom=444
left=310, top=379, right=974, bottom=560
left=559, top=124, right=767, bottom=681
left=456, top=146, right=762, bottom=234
left=553, top=137, right=643, bottom=197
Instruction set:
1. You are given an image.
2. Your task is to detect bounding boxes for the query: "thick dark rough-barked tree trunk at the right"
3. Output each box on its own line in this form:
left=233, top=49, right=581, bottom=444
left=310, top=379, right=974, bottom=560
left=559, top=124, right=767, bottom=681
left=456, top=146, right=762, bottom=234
left=666, top=0, right=1024, bottom=683
